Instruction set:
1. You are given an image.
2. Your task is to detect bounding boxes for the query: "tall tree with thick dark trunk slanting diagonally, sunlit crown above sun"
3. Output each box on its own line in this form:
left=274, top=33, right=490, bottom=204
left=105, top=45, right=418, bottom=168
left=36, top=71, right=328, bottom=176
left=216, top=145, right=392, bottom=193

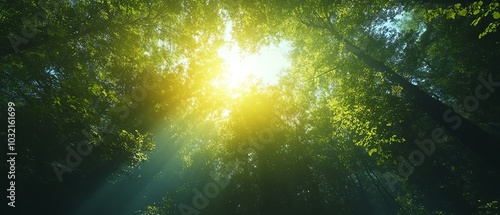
left=223, top=1, right=500, bottom=171
